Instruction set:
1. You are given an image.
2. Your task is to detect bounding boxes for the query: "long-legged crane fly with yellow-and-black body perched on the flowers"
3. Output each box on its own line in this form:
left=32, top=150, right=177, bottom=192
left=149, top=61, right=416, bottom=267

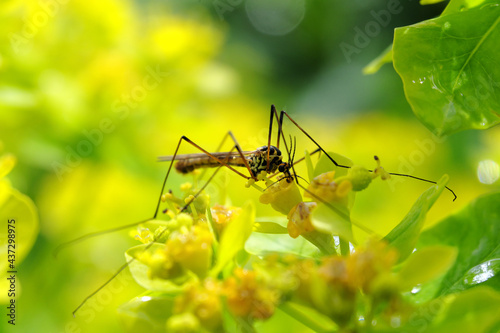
left=56, top=105, right=456, bottom=315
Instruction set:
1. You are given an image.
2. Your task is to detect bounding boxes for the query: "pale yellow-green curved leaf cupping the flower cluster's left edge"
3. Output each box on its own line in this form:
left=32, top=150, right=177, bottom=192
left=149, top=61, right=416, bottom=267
left=125, top=243, right=189, bottom=293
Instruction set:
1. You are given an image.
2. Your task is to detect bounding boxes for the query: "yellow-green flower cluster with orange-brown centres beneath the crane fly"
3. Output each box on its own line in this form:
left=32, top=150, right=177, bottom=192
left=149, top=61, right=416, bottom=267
left=121, top=154, right=446, bottom=332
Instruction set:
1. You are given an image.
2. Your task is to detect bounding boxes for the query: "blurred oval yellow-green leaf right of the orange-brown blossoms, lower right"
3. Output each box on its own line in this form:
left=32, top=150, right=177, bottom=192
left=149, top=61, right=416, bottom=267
left=398, top=245, right=458, bottom=291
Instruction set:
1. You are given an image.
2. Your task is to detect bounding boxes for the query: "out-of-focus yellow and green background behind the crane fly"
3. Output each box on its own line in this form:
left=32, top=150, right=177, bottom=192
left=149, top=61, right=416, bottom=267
left=0, top=0, right=500, bottom=332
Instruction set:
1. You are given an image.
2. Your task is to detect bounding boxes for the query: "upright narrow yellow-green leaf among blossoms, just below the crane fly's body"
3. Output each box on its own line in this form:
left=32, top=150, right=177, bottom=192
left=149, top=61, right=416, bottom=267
left=212, top=202, right=255, bottom=275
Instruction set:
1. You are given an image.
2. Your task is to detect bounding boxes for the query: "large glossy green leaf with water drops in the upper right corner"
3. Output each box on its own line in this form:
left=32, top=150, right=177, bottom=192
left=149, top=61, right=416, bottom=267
left=393, top=1, right=500, bottom=136
